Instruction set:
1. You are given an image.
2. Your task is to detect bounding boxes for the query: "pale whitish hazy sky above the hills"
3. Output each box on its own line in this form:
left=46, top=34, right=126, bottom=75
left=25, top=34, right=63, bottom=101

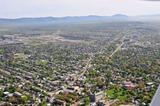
left=0, top=0, right=160, bottom=18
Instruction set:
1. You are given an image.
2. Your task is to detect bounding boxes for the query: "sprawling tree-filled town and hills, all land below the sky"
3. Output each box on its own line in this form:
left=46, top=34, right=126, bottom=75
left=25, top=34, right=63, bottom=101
left=0, top=1, right=160, bottom=106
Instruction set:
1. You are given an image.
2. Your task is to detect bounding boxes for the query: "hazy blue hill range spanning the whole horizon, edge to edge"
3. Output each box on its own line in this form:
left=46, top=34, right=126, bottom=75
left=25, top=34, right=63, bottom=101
left=0, top=14, right=160, bottom=25
